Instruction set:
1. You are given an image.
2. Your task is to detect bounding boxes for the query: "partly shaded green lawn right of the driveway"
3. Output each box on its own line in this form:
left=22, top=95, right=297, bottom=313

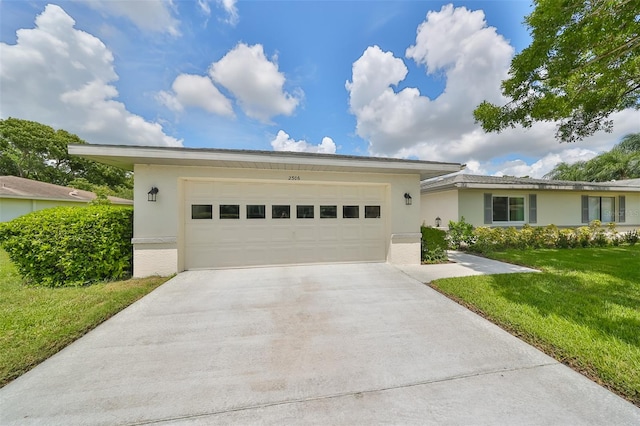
left=431, top=246, right=640, bottom=406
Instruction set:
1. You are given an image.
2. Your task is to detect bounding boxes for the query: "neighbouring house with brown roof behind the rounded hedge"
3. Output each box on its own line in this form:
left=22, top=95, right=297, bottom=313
left=0, top=176, right=133, bottom=222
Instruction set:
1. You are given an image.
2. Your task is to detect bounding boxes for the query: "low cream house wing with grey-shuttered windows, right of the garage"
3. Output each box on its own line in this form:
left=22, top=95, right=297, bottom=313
left=420, top=174, right=640, bottom=231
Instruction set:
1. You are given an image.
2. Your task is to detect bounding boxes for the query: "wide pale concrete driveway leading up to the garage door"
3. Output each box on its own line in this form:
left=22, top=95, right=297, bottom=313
left=0, top=264, right=640, bottom=425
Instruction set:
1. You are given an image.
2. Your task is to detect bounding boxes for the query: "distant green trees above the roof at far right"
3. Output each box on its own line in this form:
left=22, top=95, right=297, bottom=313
left=545, top=133, right=640, bottom=182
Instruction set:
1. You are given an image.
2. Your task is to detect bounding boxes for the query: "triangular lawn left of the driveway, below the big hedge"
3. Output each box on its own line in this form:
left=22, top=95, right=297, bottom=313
left=0, top=249, right=167, bottom=387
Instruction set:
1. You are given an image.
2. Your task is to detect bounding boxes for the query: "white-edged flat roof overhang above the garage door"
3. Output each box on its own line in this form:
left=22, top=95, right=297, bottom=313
left=68, top=144, right=464, bottom=180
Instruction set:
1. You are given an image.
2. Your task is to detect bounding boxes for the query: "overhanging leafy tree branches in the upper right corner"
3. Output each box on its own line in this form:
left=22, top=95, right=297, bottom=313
left=474, top=0, right=640, bottom=142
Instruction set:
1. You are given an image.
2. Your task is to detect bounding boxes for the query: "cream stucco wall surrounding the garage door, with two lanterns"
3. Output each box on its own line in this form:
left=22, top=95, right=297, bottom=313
left=133, top=165, right=422, bottom=276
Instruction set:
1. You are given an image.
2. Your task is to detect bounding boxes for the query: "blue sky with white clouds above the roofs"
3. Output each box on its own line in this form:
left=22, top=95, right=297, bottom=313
left=0, top=0, right=640, bottom=177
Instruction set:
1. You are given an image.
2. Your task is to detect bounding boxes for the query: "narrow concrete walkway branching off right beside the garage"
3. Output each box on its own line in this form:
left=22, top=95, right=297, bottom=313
left=397, top=251, right=540, bottom=283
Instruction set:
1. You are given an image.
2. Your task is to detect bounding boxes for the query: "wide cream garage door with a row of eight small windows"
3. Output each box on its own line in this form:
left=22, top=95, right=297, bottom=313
left=184, top=180, right=387, bottom=269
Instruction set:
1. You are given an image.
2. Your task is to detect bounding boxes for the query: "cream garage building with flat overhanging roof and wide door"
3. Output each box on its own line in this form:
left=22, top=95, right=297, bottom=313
left=69, top=144, right=462, bottom=277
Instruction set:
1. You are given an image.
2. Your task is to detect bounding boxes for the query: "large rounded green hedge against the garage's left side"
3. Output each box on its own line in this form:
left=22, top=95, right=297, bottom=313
left=0, top=205, right=133, bottom=287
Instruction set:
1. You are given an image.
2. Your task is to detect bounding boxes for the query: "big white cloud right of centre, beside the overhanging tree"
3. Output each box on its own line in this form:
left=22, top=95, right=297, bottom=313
left=346, top=5, right=513, bottom=156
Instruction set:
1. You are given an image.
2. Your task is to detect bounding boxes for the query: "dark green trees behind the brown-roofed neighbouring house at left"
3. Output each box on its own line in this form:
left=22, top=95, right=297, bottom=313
left=0, top=118, right=132, bottom=198
